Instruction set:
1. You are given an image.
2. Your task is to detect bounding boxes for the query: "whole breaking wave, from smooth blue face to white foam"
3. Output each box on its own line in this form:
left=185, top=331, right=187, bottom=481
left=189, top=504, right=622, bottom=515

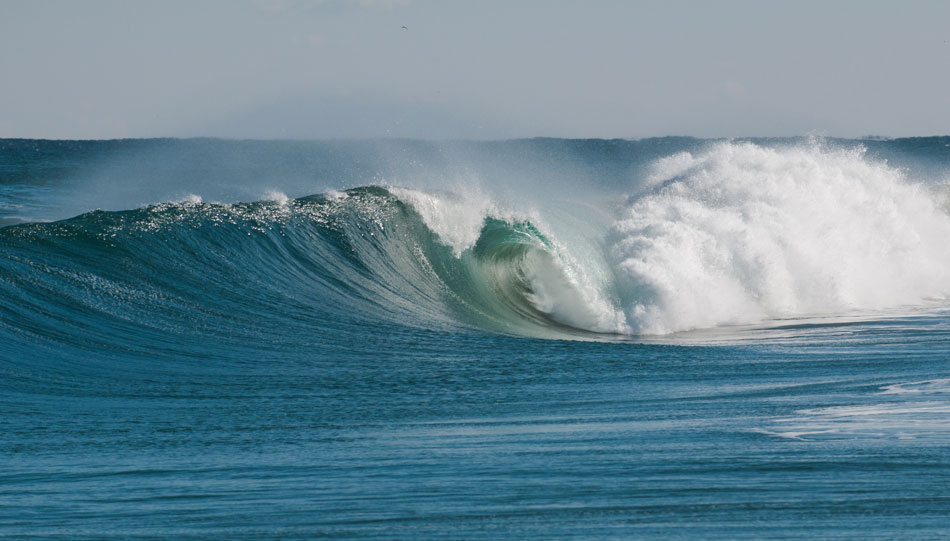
left=0, top=137, right=950, bottom=351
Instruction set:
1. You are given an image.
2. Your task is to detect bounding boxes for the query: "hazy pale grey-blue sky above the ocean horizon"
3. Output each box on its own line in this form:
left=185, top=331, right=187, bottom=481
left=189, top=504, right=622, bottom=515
left=0, top=0, right=950, bottom=139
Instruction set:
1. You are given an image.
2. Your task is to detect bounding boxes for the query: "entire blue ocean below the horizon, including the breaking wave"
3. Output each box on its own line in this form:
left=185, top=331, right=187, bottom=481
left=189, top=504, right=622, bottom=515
left=0, top=137, right=950, bottom=540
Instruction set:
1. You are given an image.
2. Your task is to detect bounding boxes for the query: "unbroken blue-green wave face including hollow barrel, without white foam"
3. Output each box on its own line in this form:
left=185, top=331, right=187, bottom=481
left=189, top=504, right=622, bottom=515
left=0, top=187, right=622, bottom=358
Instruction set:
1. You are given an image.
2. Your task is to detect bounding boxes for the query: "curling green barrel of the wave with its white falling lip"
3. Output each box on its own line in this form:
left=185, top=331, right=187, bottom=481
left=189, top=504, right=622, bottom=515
left=390, top=188, right=629, bottom=337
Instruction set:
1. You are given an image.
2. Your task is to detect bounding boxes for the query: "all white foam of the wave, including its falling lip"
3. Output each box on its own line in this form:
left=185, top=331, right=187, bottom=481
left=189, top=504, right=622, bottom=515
left=394, top=140, right=950, bottom=334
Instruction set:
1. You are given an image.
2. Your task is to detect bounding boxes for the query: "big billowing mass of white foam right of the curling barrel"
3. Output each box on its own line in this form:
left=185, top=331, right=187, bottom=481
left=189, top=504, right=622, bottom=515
left=609, top=142, right=950, bottom=334
